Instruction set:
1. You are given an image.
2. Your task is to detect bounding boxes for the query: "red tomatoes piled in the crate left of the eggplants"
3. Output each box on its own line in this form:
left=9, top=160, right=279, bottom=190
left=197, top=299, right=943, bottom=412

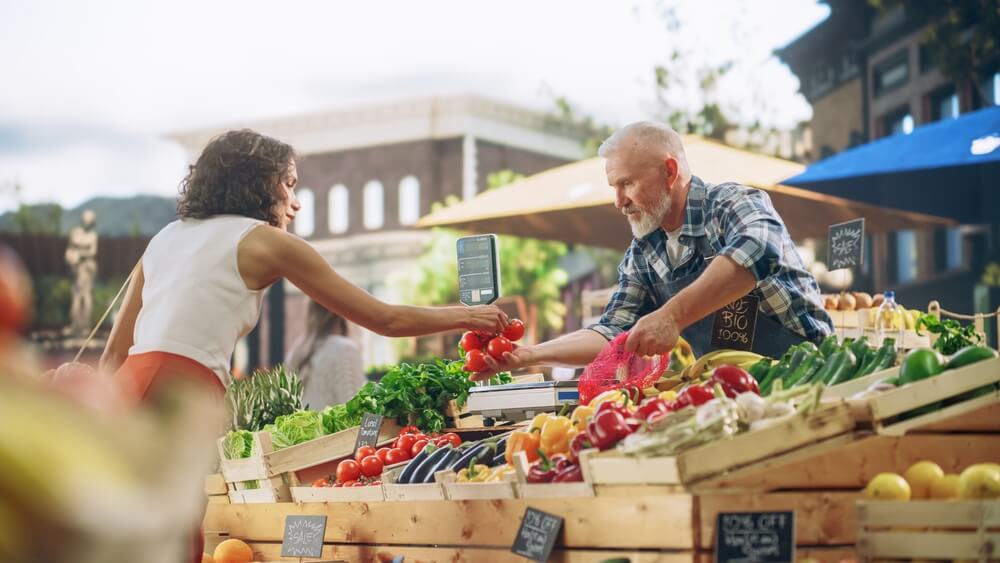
left=313, top=426, right=462, bottom=487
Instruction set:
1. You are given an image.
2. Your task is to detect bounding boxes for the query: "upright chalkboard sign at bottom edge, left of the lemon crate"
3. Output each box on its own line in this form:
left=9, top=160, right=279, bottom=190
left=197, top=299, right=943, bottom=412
left=715, top=511, right=795, bottom=563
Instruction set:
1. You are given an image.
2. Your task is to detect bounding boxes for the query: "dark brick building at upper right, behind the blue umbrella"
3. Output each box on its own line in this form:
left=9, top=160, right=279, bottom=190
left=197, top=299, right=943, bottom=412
left=776, top=0, right=1000, bottom=307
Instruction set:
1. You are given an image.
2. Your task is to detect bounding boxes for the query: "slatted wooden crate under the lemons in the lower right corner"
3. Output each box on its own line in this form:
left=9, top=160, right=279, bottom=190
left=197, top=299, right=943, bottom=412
left=857, top=500, right=1000, bottom=561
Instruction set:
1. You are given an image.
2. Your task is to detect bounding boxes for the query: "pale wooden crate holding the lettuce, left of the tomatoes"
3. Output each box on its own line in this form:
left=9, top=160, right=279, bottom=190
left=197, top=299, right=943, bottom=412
left=217, top=419, right=400, bottom=503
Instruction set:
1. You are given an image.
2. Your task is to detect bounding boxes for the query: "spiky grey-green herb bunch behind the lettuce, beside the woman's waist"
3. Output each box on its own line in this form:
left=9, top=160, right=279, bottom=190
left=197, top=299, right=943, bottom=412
left=226, top=365, right=302, bottom=432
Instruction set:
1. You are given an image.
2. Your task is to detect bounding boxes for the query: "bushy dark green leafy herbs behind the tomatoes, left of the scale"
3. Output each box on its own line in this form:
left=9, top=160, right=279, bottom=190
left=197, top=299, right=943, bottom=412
left=346, top=360, right=510, bottom=432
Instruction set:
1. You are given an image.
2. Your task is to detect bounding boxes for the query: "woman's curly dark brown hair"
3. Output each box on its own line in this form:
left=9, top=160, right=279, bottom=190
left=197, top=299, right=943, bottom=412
left=177, top=129, right=295, bottom=226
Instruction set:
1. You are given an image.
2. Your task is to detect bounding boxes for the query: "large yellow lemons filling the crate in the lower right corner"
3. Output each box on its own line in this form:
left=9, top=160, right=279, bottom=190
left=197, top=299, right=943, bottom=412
left=865, top=460, right=1000, bottom=501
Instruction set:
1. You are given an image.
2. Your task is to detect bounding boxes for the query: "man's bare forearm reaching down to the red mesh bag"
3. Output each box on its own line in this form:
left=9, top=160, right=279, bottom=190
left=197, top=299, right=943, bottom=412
left=661, top=256, right=756, bottom=330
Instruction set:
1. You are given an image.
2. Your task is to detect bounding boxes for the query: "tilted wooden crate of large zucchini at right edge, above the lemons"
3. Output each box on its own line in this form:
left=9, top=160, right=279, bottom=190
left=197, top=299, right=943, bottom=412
left=849, top=358, right=1000, bottom=436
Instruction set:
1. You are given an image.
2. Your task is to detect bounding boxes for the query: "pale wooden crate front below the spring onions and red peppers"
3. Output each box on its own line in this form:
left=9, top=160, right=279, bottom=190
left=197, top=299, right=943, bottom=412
left=589, top=402, right=854, bottom=485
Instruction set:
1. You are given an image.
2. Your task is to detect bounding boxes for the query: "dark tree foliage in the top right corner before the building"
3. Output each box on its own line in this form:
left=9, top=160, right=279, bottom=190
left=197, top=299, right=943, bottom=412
left=868, top=0, right=1000, bottom=104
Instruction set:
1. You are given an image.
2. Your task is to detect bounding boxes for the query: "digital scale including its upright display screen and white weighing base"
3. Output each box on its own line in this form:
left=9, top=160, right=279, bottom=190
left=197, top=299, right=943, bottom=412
left=456, top=235, right=580, bottom=425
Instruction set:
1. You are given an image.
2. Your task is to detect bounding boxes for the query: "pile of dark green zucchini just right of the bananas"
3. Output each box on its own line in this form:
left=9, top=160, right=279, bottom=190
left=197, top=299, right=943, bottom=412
left=750, top=336, right=896, bottom=396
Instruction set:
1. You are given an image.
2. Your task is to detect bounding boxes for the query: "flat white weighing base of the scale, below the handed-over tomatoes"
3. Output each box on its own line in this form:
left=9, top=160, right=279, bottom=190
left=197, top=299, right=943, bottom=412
left=467, top=381, right=580, bottom=422
